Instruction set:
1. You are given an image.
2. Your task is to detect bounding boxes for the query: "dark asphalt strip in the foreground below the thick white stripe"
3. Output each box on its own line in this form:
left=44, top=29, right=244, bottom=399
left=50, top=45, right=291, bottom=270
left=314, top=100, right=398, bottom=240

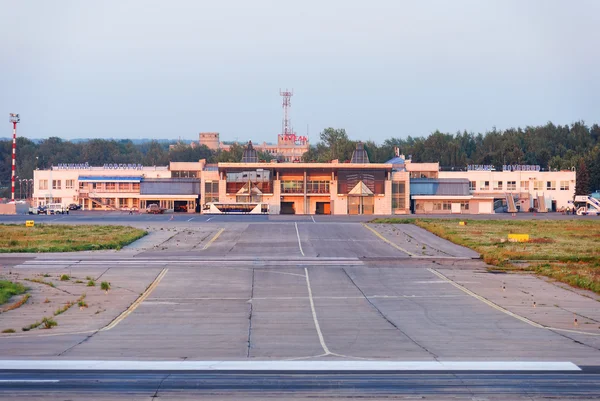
left=0, top=368, right=600, bottom=400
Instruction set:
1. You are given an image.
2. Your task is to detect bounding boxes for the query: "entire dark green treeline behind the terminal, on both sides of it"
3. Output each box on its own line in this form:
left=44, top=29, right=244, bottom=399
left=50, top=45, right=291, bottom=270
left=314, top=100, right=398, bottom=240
left=0, top=122, right=600, bottom=197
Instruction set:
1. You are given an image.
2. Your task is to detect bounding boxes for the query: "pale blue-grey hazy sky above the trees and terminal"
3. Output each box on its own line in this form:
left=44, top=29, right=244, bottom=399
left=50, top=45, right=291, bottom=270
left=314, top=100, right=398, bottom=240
left=0, top=0, right=600, bottom=143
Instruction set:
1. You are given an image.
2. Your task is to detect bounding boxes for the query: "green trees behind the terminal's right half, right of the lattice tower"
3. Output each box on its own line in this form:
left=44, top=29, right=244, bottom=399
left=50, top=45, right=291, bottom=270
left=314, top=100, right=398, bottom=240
left=303, top=122, right=600, bottom=193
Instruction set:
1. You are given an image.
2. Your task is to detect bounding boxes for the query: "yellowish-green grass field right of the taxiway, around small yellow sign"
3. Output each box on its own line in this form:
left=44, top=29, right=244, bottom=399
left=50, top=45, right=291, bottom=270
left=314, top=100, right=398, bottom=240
left=372, top=218, right=600, bottom=294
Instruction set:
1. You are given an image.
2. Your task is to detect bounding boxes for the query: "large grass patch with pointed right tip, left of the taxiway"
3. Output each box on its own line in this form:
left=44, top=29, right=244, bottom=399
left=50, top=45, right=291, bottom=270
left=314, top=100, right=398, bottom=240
left=0, top=224, right=148, bottom=253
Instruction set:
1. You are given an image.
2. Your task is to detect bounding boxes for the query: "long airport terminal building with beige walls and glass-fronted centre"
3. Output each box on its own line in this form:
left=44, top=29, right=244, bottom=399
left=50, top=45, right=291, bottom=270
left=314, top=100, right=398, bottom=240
left=33, top=142, right=575, bottom=215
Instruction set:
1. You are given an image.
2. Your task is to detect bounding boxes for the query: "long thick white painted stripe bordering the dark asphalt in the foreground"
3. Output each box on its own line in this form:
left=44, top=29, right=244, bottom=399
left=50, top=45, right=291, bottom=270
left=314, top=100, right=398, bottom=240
left=0, top=360, right=581, bottom=371
